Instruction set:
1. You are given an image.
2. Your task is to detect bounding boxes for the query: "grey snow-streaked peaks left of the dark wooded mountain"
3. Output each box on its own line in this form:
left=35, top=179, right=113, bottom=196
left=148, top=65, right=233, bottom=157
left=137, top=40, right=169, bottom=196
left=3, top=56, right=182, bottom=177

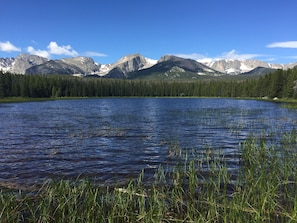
left=0, top=54, right=157, bottom=78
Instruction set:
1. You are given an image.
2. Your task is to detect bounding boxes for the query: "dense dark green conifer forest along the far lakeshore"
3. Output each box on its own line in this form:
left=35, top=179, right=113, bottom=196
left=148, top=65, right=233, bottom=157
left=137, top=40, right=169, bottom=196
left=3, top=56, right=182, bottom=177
left=0, top=68, right=297, bottom=98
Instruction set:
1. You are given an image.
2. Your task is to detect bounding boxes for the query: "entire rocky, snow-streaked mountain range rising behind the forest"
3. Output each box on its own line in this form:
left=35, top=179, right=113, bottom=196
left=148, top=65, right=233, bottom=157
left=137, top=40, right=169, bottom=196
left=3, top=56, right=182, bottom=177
left=0, top=54, right=297, bottom=79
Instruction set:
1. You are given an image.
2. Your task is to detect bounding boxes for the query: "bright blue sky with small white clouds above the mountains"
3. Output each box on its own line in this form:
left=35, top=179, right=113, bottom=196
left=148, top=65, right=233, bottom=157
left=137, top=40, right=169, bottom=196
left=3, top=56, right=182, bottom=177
left=0, top=0, right=297, bottom=64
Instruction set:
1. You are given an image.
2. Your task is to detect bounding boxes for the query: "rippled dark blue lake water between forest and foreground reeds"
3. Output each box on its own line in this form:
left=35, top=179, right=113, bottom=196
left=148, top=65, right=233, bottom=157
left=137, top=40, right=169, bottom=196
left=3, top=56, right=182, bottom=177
left=0, top=98, right=297, bottom=185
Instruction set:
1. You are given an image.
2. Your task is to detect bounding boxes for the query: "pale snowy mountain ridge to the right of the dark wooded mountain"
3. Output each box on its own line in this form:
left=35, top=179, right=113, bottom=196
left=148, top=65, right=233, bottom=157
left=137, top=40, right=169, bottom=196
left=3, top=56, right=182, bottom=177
left=204, top=60, right=285, bottom=75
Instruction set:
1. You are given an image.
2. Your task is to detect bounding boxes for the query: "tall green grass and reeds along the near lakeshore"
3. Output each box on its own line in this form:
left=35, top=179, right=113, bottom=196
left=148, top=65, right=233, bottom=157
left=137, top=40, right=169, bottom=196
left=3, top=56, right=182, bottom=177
left=0, top=131, right=297, bottom=223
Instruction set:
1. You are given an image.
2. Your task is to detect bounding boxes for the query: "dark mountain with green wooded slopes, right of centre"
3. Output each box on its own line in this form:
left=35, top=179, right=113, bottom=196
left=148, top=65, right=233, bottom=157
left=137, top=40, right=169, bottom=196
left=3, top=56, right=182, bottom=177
left=129, top=55, right=222, bottom=79
